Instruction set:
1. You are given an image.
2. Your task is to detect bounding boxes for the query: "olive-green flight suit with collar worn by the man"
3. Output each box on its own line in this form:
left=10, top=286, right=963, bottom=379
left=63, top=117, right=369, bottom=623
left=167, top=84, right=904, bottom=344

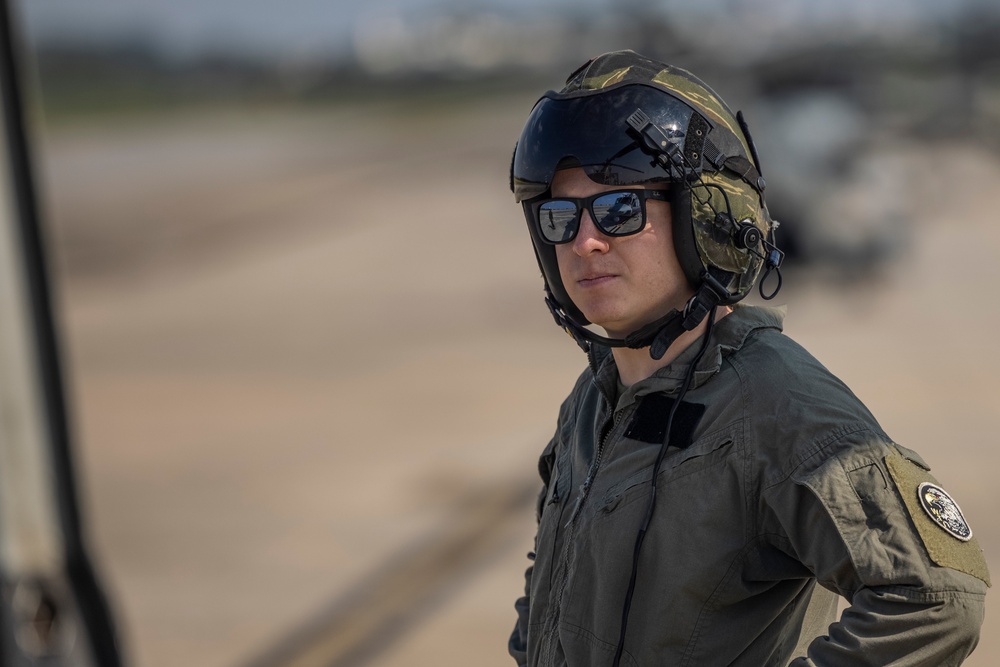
left=509, top=306, right=989, bottom=667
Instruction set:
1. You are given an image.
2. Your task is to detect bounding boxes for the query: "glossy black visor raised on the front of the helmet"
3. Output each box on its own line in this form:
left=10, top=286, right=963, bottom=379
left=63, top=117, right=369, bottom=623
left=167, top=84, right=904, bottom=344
left=513, top=84, right=695, bottom=201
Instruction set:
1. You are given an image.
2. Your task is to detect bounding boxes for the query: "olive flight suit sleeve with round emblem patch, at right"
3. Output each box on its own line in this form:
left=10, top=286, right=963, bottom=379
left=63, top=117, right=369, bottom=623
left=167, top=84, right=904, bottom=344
left=766, top=432, right=989, bottom=667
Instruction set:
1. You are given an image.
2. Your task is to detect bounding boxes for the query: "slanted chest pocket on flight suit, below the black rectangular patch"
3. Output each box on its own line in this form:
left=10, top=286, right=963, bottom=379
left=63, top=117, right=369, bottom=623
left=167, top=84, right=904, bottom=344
left=597, top=427, right=737, bottom=514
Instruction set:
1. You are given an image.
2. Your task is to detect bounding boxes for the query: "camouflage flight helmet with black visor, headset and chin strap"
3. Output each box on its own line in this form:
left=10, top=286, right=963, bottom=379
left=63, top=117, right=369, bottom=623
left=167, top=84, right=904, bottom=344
left=511, top=51, right=784, bottom=359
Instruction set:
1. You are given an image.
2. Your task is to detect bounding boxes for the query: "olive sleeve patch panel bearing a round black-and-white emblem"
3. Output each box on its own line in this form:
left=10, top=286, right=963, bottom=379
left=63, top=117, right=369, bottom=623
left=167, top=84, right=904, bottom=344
left=885, top=454, right=991, bottom=586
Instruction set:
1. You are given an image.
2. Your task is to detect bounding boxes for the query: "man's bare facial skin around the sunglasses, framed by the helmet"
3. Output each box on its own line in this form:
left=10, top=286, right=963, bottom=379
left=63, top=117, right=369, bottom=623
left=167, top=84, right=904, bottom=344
left=552, top=168, right=694, bottom=338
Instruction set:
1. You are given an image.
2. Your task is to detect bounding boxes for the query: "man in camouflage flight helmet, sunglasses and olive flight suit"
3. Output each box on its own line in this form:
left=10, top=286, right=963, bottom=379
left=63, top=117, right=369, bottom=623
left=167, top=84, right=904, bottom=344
left=510, top=51, right=989, bottom=667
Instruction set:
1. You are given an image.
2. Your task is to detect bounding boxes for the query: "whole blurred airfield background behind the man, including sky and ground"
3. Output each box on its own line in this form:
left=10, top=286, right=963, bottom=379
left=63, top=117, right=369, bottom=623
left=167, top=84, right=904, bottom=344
left=5, top=0, right=1000, bottom=667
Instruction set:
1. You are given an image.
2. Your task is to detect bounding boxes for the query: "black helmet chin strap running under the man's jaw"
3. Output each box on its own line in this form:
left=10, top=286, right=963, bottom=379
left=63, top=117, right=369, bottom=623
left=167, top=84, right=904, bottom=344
left=545, top=272, right=729, bottom=361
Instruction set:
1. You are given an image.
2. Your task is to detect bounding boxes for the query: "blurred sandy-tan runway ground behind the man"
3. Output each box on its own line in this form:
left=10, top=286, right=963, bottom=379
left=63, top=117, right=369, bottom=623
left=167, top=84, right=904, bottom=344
left=35, top=95, right=1000, bottom=667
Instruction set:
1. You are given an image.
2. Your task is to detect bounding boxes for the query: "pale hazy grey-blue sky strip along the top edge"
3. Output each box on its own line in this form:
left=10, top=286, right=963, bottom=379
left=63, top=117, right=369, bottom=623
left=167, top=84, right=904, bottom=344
left=15, top=0, right=968, bottom=58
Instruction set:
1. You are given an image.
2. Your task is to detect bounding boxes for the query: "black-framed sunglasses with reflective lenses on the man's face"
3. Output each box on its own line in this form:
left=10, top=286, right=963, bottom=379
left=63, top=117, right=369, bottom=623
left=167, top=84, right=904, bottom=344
left=531, top=190, right=669, bottom=245
